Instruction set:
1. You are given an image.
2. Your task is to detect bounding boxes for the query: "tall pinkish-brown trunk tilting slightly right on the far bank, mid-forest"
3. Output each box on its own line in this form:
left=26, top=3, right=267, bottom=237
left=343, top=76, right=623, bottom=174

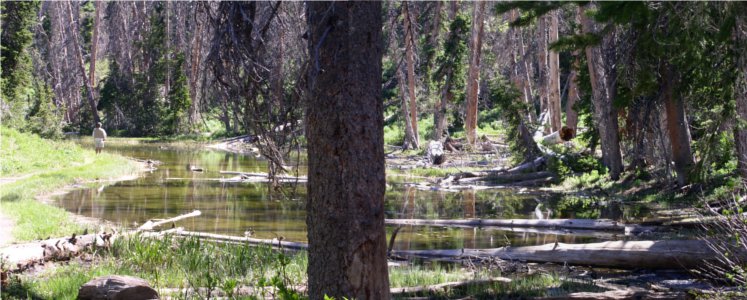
left=465, top=1, right=485, bottom=145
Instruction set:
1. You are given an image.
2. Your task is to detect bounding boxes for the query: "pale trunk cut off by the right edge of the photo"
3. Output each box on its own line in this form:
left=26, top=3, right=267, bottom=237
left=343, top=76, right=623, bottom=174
left=734, top=14, right=747, bottom=181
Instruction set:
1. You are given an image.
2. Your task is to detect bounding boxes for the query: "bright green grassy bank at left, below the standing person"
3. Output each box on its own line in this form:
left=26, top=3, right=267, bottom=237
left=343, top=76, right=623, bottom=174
left=0, top=128, right=139, bottom=241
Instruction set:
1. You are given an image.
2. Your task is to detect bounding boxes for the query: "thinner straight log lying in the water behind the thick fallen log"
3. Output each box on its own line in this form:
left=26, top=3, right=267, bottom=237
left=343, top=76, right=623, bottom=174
left=385, top=219, right=625, bottom=232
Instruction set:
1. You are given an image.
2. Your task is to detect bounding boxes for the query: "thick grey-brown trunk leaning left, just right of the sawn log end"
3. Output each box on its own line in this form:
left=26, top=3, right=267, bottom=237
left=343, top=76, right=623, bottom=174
left=581, top=5, right=623, bottom=180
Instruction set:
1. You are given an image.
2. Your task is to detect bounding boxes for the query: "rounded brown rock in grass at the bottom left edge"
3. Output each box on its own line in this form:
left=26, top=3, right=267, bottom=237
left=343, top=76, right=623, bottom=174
left=78, top=275, right=159, bottom=300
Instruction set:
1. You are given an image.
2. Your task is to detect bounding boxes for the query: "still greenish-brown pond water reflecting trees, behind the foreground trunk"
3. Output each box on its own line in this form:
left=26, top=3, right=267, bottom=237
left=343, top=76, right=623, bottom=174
left=56, top=139, right=646, bottom=250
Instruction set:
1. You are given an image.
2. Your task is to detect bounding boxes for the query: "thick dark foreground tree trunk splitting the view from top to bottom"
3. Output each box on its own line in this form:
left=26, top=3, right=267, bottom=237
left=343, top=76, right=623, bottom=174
left=306, top=2, right=390, bottom=299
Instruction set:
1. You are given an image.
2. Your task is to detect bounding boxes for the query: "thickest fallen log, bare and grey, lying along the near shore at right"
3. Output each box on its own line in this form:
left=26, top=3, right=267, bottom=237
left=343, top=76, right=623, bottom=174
left=392, top=240, right=716, bottom=269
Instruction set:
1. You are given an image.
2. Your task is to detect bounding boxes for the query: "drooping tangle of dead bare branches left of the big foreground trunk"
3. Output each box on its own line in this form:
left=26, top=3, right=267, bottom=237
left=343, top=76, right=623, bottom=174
left=205, top=2, right=302, bottom=186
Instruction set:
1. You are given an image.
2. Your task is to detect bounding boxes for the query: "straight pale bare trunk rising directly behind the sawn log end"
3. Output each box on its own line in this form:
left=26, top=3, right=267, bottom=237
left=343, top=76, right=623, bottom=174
left=547, top=10, right=562, bottom=132
